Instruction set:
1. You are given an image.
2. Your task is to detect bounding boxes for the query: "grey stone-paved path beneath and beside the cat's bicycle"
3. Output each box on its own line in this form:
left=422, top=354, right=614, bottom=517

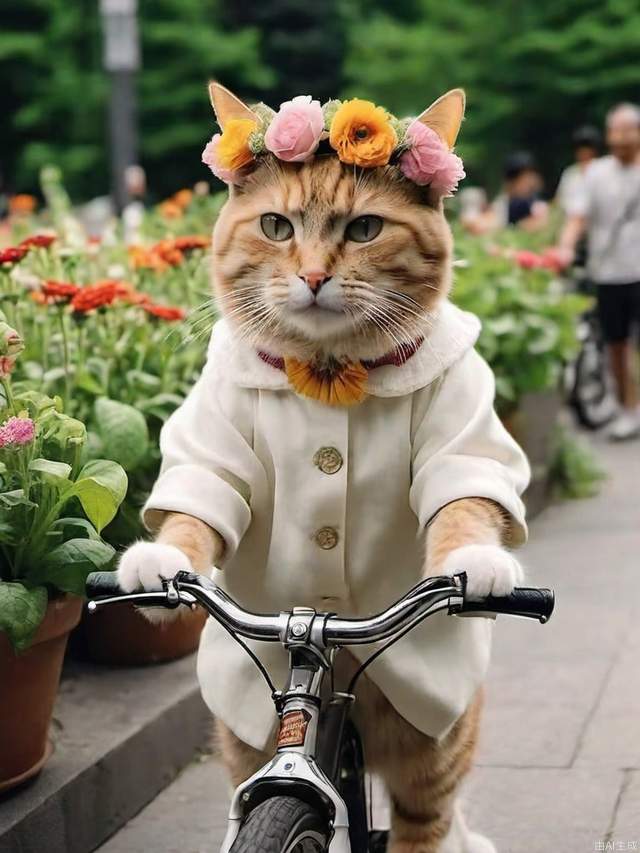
left=100, top=432, right=640, bottom=853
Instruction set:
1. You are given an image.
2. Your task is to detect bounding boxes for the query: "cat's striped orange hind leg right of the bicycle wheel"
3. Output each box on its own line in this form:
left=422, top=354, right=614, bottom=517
left=355, top=656, right=484, bottom=853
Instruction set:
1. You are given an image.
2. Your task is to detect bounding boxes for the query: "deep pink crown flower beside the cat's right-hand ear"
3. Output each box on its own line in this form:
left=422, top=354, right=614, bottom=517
left=400, top=119, right=465, bottom=196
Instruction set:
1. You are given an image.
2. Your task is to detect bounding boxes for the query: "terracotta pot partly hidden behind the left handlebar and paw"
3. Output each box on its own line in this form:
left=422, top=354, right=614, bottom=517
left=73, top=604, right=207, bottom=666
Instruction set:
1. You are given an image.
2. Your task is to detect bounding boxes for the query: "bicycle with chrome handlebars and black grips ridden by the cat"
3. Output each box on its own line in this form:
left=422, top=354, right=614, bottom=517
left=87, top=572, right=554, bottom=853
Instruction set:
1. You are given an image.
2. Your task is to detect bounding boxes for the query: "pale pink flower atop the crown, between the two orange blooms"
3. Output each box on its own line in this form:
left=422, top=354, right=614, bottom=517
left=264, top=95, right=324, bottom=163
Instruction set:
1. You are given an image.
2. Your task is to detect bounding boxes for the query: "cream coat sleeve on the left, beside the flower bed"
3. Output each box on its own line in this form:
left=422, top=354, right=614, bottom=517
left=142, top=362, right=264, bottom=562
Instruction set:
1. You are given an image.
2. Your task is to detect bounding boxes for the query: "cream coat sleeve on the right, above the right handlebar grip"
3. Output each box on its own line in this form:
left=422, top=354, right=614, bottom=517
left=410, top=350, right=530, bottom=546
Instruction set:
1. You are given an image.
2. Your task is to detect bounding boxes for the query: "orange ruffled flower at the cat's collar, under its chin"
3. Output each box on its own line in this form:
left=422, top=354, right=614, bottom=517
left=284, top=358, right=368, bottom=406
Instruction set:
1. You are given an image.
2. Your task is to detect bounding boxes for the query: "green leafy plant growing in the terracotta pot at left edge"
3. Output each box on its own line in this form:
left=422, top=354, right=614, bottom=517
left=0, top=388, right=127, bottom=651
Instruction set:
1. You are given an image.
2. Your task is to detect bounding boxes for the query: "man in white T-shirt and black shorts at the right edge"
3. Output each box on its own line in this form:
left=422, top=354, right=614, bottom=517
left=559, top=103, right=640, bottom=440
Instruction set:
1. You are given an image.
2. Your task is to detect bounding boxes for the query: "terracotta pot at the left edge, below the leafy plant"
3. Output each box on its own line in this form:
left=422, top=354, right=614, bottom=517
left=0, top=595, right=82, bottom=791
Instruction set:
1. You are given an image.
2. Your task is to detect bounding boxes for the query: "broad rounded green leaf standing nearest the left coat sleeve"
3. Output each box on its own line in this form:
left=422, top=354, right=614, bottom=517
left=95, top=397, right=149, bottom=471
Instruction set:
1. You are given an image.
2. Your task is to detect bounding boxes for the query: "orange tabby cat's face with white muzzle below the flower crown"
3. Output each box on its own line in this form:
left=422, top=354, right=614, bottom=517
left=214, top=156, right=451, bottom=358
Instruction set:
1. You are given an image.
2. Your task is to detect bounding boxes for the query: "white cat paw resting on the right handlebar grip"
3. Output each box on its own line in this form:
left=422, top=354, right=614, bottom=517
left=442, top=545, right=524, bottom=599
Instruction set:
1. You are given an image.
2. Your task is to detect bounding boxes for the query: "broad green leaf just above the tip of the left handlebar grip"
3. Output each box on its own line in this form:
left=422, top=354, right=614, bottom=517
left=27, top=539, right=116, bottom=595
